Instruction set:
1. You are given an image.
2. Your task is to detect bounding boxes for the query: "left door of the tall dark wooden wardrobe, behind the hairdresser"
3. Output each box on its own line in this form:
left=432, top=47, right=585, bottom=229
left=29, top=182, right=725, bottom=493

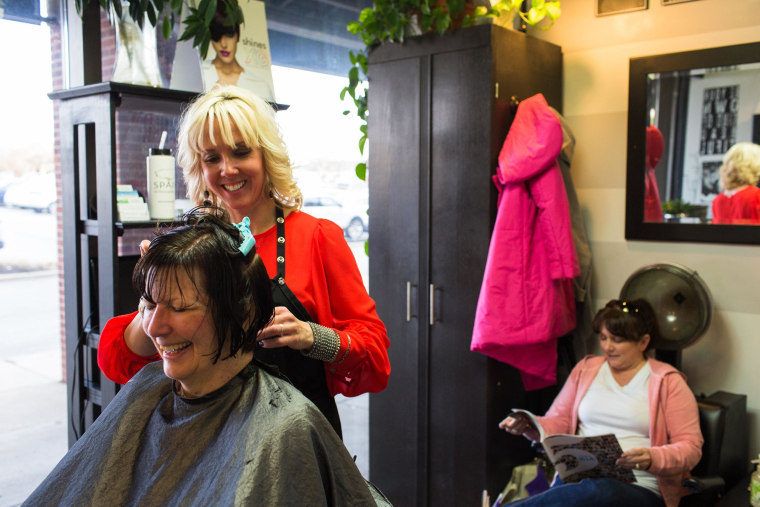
left=368, top=53, right=425, bottom=506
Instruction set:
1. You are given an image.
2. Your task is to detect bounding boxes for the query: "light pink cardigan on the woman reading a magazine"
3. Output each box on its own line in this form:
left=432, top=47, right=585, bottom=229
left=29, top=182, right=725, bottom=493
left=538, top=356, right=703, bottom=507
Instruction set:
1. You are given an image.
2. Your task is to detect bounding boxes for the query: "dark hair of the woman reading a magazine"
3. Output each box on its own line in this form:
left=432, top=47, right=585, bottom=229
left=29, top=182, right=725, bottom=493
left=591, top=299, right=660, bottom=350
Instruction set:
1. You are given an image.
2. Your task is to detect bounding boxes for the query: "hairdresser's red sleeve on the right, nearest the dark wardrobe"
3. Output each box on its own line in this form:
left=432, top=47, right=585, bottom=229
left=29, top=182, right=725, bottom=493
left=314, top=220, right=391, bottom=396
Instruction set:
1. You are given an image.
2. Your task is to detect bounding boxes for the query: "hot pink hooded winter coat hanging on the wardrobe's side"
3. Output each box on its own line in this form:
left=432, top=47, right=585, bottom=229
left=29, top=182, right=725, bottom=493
left=470, top=94, right=580, bottom=390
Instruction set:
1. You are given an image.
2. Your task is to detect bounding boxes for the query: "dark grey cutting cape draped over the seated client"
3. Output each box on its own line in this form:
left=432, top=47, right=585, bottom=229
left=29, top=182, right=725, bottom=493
left=24, top=361, right=375, bottom=506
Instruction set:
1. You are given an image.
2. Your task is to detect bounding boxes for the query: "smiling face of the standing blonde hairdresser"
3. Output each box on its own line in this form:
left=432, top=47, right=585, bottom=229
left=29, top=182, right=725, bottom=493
left=201, top=122, right=271, bottom=222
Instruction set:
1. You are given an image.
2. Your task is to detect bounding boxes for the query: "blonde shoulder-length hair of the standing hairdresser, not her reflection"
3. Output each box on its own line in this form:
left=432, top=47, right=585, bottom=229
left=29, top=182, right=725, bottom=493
left=177, top=86, right=303, bottom=209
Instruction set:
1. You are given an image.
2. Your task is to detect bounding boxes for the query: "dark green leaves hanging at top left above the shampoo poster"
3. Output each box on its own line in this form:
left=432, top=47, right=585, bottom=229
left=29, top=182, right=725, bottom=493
left=74, top=0, right=243, bottom=59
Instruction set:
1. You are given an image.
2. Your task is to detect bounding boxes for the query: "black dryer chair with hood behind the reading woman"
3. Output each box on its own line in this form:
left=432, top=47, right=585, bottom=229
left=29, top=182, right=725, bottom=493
left=620, top=263, right=749, bottom=507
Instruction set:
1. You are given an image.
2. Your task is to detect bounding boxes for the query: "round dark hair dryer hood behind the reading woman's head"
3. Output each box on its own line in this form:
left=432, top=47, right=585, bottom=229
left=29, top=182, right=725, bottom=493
left=620, top=263, right=712, bottom=350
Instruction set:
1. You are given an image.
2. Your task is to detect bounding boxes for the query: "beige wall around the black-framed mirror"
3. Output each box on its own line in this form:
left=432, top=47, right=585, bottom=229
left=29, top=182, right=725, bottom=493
left=533, top=0, right=760, bottom=456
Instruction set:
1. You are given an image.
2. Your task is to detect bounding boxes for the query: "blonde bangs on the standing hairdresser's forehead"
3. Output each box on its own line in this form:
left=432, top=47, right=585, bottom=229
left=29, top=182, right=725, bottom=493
left=198, top=99, right=261, bottom=152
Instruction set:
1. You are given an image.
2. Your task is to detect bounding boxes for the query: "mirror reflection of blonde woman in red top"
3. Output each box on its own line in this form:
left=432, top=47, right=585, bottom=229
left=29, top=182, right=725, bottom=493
left=712, top=142, right=760, bottom=225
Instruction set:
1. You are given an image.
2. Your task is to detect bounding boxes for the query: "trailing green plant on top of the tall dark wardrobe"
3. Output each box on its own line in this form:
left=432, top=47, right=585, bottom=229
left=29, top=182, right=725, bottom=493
left=340, top=0, right=561, bottom=180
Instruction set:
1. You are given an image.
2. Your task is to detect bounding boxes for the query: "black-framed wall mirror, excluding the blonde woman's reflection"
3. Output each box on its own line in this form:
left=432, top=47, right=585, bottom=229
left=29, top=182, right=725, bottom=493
left=625, top=42, right=760, bottom=244
